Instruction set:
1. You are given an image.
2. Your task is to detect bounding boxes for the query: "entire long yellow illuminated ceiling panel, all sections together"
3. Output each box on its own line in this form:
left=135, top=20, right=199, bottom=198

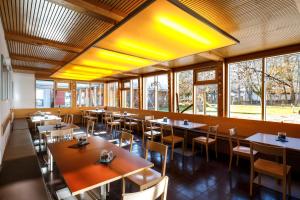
left=51, top=0, right=238, bottom=80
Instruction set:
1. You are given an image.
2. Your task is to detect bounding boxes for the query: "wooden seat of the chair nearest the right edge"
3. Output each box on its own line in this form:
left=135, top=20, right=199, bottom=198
left=254, top=158, right=291, bottom=177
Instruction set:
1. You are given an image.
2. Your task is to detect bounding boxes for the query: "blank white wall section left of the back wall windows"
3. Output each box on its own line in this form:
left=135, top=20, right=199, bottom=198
left=13, top=73, right=35, bottom=109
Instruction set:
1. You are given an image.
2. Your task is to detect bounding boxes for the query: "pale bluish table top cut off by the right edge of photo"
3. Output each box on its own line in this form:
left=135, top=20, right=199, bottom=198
left=246, top=133, right=300, bottom=151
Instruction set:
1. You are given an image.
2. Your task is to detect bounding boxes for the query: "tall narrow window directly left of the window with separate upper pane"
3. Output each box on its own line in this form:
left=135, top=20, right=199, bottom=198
left=174, top=70, right=193, bottom=113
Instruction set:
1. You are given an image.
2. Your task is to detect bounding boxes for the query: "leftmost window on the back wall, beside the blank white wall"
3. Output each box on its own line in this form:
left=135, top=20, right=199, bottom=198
left=35, top=80, right=54, bottom=108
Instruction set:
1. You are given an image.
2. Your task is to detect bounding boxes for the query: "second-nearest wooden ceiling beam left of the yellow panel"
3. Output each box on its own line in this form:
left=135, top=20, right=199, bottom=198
left=5, top=32, right=83, bottom=53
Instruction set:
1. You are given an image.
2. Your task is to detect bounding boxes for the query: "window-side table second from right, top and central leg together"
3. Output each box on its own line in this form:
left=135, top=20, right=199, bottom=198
left=149, top=118, right=207, bottom=153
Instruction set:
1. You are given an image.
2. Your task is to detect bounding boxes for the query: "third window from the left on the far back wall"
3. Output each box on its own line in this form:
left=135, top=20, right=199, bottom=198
left=76, top=83, right=90, bottom=107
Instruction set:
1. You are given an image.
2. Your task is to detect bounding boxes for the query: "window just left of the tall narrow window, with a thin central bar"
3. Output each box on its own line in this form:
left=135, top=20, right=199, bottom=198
left=144, top=74, right=169, bottom=111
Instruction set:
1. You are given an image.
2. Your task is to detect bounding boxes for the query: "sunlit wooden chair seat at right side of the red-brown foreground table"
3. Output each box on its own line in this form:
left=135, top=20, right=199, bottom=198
left=127, top=168, right=161, bottom=187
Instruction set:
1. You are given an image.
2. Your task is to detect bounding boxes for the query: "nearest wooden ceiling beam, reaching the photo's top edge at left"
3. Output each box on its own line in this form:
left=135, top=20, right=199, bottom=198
left=48, top=0, right=125, bottom=24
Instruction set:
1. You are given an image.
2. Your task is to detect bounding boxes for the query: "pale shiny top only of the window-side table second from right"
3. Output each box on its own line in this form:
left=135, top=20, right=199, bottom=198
left=150, top=119, right=207, bottom=130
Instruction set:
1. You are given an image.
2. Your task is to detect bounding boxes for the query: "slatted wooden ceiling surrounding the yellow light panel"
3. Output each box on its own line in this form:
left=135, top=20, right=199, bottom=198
left=0, top=0, right=300, bottom=78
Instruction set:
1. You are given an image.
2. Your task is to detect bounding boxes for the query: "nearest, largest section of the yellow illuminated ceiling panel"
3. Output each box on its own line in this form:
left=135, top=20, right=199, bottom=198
left=95, top=0, right=238, bottom=61
